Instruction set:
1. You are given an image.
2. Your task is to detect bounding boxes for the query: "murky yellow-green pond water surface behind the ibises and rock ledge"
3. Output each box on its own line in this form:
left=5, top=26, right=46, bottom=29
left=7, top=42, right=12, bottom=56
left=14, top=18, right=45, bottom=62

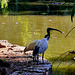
left=0, top=15, right=75, bottom=75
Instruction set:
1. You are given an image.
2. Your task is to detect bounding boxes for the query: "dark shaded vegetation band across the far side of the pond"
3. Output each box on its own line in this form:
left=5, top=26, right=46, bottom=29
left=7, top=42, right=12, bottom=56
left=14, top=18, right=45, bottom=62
left=1, top=0, right=75, bottom=17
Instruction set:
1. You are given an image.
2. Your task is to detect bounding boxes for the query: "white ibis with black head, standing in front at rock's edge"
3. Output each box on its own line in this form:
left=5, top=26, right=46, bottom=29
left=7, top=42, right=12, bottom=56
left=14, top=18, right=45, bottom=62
left=33, top=28, right=62, bottom=63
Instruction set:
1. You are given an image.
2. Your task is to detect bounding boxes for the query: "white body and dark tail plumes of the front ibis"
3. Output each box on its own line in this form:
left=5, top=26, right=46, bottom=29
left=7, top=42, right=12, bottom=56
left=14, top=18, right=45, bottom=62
left=33, top=38, right=48, bottom=56
